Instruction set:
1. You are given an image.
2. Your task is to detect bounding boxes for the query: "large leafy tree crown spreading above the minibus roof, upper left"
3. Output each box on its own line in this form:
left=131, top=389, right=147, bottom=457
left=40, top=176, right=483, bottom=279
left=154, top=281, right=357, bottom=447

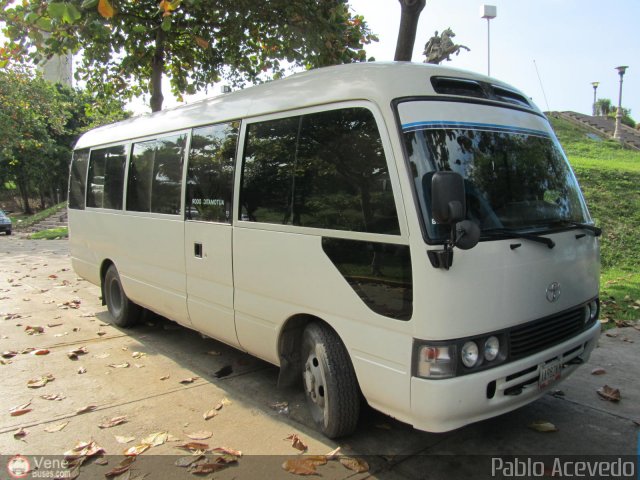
left=0, top=0, right=377, bottom=111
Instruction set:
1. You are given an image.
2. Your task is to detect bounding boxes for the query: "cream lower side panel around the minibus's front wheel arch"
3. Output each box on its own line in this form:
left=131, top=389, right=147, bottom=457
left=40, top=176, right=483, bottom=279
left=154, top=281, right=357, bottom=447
left=233, top=227, right=412, bottom=419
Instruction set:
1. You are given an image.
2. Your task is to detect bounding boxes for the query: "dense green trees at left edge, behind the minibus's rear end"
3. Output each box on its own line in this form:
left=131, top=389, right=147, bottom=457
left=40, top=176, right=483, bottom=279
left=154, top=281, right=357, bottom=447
left=0, top=68, right=127, bottom=213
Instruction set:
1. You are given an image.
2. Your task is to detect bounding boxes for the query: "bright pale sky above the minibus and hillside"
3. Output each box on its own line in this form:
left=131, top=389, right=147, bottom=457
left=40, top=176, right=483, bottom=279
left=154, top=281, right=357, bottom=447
left=132, top=0, right=640, bottom=121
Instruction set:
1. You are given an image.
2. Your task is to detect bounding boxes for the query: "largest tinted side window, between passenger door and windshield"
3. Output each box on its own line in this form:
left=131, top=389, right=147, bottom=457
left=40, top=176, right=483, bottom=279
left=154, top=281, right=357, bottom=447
left=241, top=108, right=400, bottom=234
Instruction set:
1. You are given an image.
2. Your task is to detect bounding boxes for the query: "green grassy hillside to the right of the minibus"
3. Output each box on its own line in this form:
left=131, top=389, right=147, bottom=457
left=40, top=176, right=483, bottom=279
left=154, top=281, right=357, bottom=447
left=550, top=118, right=640, bottom=320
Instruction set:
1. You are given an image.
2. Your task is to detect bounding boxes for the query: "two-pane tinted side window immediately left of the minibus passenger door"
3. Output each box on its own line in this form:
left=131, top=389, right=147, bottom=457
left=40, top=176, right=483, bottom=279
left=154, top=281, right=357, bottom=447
left=127, top=134, right=187, bottom=215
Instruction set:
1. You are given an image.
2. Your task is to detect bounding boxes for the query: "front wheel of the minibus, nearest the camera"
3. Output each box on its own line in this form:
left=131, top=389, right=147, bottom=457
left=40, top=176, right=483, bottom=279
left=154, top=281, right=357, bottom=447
left=302, top=323, right=360, bottom=438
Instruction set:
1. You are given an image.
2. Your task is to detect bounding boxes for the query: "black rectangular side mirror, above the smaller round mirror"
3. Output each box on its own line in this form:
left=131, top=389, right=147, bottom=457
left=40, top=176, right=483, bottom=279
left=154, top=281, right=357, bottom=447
left=431, top=172, right=467, bottom=227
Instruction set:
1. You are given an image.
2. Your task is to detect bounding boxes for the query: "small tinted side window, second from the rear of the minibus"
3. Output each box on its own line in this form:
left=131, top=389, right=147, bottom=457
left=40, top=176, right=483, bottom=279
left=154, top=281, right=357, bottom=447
left=87, top=145, right=127, bottom=210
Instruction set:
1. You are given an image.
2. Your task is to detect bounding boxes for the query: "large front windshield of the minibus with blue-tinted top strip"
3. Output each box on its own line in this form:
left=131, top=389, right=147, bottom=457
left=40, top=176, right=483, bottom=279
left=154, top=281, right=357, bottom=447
left=404, top=122, right=591, bottom=241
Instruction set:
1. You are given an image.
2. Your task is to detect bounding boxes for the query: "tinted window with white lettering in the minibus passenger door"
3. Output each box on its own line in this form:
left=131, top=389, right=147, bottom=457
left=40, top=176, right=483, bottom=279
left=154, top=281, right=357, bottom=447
left=185, top=122, right=240, bottom=223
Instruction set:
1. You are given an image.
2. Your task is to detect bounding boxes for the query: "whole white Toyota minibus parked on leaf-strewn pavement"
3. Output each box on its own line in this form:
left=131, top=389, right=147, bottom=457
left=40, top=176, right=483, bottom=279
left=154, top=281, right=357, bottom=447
left=69, top=63, right=601, bottom=437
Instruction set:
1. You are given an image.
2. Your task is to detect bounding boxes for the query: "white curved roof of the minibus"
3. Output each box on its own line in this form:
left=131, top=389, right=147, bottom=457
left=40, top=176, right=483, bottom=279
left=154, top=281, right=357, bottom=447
left=75, top=62, right=539, bottom=149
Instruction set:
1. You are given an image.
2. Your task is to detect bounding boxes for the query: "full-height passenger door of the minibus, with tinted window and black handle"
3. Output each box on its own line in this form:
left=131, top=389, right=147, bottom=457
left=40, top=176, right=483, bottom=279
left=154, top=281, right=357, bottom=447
left=184, top=122, right=240, bottom=346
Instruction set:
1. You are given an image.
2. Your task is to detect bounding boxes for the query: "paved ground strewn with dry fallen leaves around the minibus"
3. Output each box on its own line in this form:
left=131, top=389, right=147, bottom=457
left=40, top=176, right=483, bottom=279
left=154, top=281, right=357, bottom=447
left=0, top=236, right=640, bottom=479
